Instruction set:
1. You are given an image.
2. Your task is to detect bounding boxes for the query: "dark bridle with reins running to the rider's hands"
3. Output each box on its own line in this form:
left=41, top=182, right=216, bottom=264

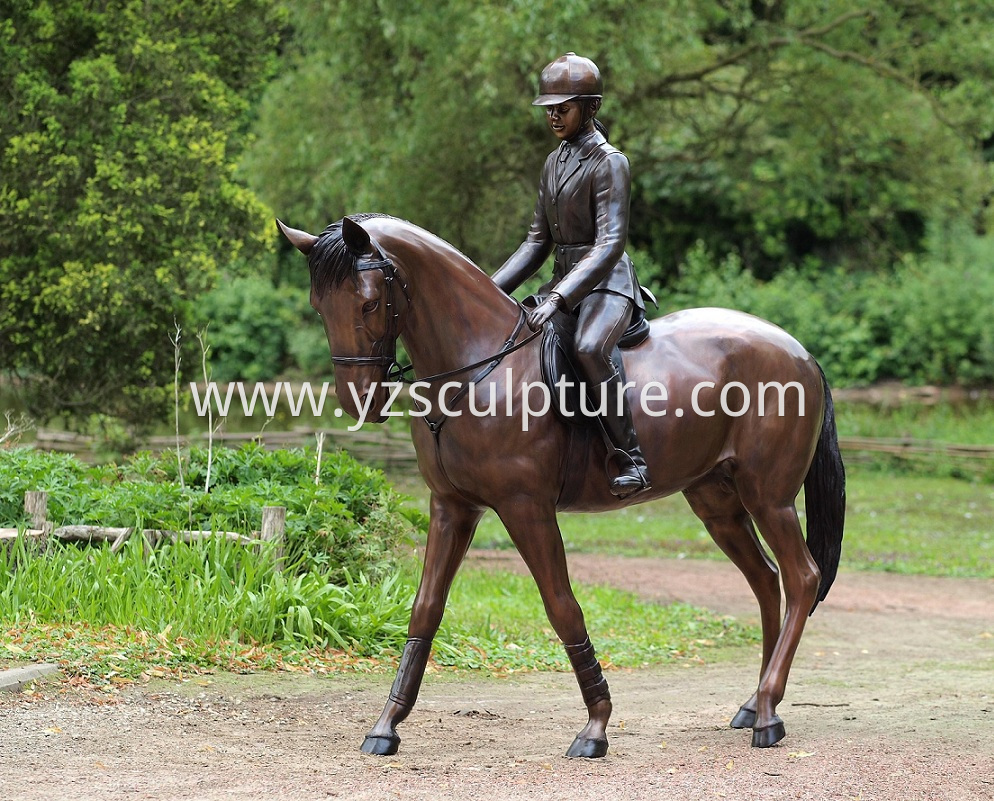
left=331, top=252, right=542, bottom=386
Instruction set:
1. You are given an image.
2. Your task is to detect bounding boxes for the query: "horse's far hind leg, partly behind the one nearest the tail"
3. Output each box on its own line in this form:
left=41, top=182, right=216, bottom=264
left=684, top=477, right=780, bottom=729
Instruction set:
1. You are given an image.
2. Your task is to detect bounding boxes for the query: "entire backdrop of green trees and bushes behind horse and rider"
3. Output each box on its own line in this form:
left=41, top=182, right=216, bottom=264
left=0, top=0, right=994, bottom=422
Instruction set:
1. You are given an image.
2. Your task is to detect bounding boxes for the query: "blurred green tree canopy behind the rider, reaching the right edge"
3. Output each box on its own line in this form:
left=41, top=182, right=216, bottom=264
left=246, top=0, right=994, bottom=280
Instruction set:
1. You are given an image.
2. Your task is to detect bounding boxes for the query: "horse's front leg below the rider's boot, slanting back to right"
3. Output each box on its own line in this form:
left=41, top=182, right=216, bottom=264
left=496, top=497, right=612, bottom=757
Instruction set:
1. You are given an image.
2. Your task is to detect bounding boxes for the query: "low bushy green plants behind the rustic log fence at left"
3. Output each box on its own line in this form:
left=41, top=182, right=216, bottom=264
left=0, top=444, right=416, bottom=583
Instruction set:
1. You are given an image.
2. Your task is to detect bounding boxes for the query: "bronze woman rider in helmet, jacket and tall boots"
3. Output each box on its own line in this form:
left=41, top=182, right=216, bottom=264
left=493, top=53, right=650, bottom=497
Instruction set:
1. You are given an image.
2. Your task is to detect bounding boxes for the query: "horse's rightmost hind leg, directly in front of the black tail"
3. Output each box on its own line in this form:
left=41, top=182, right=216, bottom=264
left=740, top=496, right=821, bottom=748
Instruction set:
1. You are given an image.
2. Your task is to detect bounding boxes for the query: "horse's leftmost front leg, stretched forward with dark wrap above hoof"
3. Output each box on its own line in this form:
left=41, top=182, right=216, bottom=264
left=361, top=494, right=483, bottom=756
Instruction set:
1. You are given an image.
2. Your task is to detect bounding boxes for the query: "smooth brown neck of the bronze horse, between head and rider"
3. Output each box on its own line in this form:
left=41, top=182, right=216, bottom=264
left=378, top=225, right=520, bottom=378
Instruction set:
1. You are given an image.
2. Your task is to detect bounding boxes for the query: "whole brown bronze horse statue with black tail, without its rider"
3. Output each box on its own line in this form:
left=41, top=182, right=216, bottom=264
left=278, top=215, right=845, bottom=757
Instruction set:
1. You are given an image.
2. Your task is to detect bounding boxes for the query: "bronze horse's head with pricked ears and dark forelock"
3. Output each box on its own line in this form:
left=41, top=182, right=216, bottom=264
left=276, top=217, right=409, bottom=423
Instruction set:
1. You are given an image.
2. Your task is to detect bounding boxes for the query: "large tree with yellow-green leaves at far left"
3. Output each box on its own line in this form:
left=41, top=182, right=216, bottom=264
left=0, top=0, right=285, bottom=420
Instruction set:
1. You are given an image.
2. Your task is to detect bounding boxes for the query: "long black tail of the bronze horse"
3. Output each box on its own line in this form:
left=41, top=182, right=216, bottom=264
left=804, top=366, right=846, bottom=612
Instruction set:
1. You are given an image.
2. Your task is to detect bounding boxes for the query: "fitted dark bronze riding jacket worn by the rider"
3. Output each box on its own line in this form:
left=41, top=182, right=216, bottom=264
left=493, top=129, right=645, bottom=309
